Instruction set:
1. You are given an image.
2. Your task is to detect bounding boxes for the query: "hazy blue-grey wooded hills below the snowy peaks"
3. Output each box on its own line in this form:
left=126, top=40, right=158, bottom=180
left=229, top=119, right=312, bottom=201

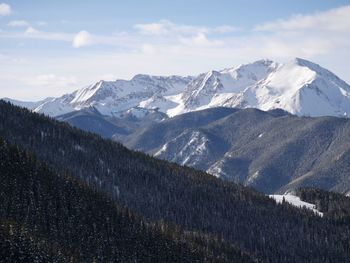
left=52, top=107, right=350, bottom=194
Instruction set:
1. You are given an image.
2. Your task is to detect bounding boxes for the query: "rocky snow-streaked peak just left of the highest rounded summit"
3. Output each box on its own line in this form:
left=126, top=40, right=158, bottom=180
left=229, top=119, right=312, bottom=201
left=167, top=60, right=278, bottom=116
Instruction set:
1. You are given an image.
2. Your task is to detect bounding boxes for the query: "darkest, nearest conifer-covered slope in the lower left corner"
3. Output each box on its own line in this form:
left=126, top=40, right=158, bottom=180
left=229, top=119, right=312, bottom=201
left=0, top=141, right=252, bottom=262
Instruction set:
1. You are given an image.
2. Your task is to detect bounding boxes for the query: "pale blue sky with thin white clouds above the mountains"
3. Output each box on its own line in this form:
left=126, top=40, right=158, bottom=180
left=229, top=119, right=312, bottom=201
left=0, top=0, right=350, bottom=101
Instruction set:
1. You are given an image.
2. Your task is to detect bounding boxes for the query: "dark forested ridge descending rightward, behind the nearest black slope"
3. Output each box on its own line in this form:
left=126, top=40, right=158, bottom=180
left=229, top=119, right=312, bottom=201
left=0, top=102, right=350, bottom=262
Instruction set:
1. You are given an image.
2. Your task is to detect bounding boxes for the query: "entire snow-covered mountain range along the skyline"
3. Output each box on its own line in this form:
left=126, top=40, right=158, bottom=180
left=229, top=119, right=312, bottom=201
left=4, top=58, right=350, bottom=117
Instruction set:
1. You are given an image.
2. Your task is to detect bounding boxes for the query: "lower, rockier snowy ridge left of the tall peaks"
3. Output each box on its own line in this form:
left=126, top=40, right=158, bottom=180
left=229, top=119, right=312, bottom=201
left=29, top=75, right=191, bottom=116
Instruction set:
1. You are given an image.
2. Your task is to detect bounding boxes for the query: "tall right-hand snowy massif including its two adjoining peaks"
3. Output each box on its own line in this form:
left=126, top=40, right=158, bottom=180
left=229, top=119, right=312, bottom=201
left=167, top=58, right=350, bottom=116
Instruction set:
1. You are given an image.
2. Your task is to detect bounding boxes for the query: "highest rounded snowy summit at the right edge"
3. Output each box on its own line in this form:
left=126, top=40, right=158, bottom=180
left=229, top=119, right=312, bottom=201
left=243, top=58, right=350, bottom=116
